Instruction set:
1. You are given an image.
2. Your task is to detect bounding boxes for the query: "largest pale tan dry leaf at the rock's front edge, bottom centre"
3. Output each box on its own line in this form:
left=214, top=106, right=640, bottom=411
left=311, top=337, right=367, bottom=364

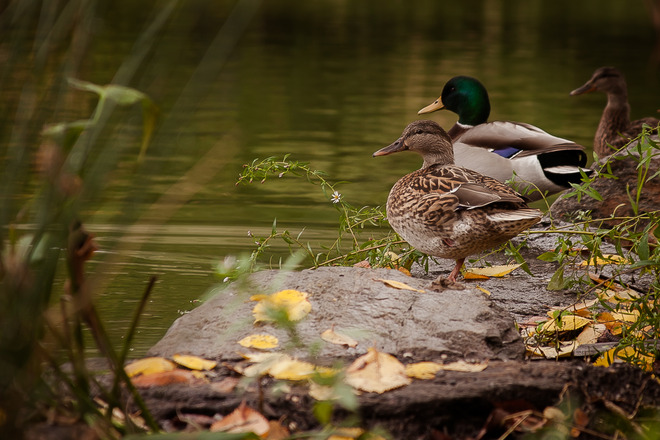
left=346, top=348, right=412, bottom=394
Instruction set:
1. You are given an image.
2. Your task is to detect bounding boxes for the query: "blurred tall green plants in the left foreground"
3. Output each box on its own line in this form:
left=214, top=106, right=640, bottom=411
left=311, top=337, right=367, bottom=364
left=0, top=74, right=158, bottom=435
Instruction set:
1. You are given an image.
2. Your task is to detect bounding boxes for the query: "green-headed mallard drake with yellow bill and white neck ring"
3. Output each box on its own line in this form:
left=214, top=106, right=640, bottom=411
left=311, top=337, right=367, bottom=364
left=418, top=76, right=591, bottom=200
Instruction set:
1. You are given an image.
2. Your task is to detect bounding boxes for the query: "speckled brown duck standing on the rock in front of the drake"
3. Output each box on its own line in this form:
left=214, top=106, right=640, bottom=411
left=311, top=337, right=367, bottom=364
left=373, top=120, right=543, bottom=285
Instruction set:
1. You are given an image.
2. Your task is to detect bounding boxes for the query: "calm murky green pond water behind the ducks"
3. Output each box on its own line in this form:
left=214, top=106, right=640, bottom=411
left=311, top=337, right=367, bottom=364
left=2, top=0, right=660, bottom=356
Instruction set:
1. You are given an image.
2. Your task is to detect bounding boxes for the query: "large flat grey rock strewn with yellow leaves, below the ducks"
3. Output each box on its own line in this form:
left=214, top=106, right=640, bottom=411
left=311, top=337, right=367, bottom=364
left=149, top=267, right=524, bottom=361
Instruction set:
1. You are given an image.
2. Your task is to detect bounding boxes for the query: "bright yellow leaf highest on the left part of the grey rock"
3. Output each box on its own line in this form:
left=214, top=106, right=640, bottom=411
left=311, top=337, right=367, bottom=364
left=250, top=290, right=312, bottom=322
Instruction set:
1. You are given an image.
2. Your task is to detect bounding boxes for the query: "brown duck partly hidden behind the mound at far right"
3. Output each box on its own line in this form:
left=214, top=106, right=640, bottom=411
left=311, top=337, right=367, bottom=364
left=571, top=67, right=660, bottom=158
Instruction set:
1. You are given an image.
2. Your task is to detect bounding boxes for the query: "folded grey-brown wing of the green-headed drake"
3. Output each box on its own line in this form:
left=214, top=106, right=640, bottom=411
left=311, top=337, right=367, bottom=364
left=454, top=121, right=584, bottom=158
